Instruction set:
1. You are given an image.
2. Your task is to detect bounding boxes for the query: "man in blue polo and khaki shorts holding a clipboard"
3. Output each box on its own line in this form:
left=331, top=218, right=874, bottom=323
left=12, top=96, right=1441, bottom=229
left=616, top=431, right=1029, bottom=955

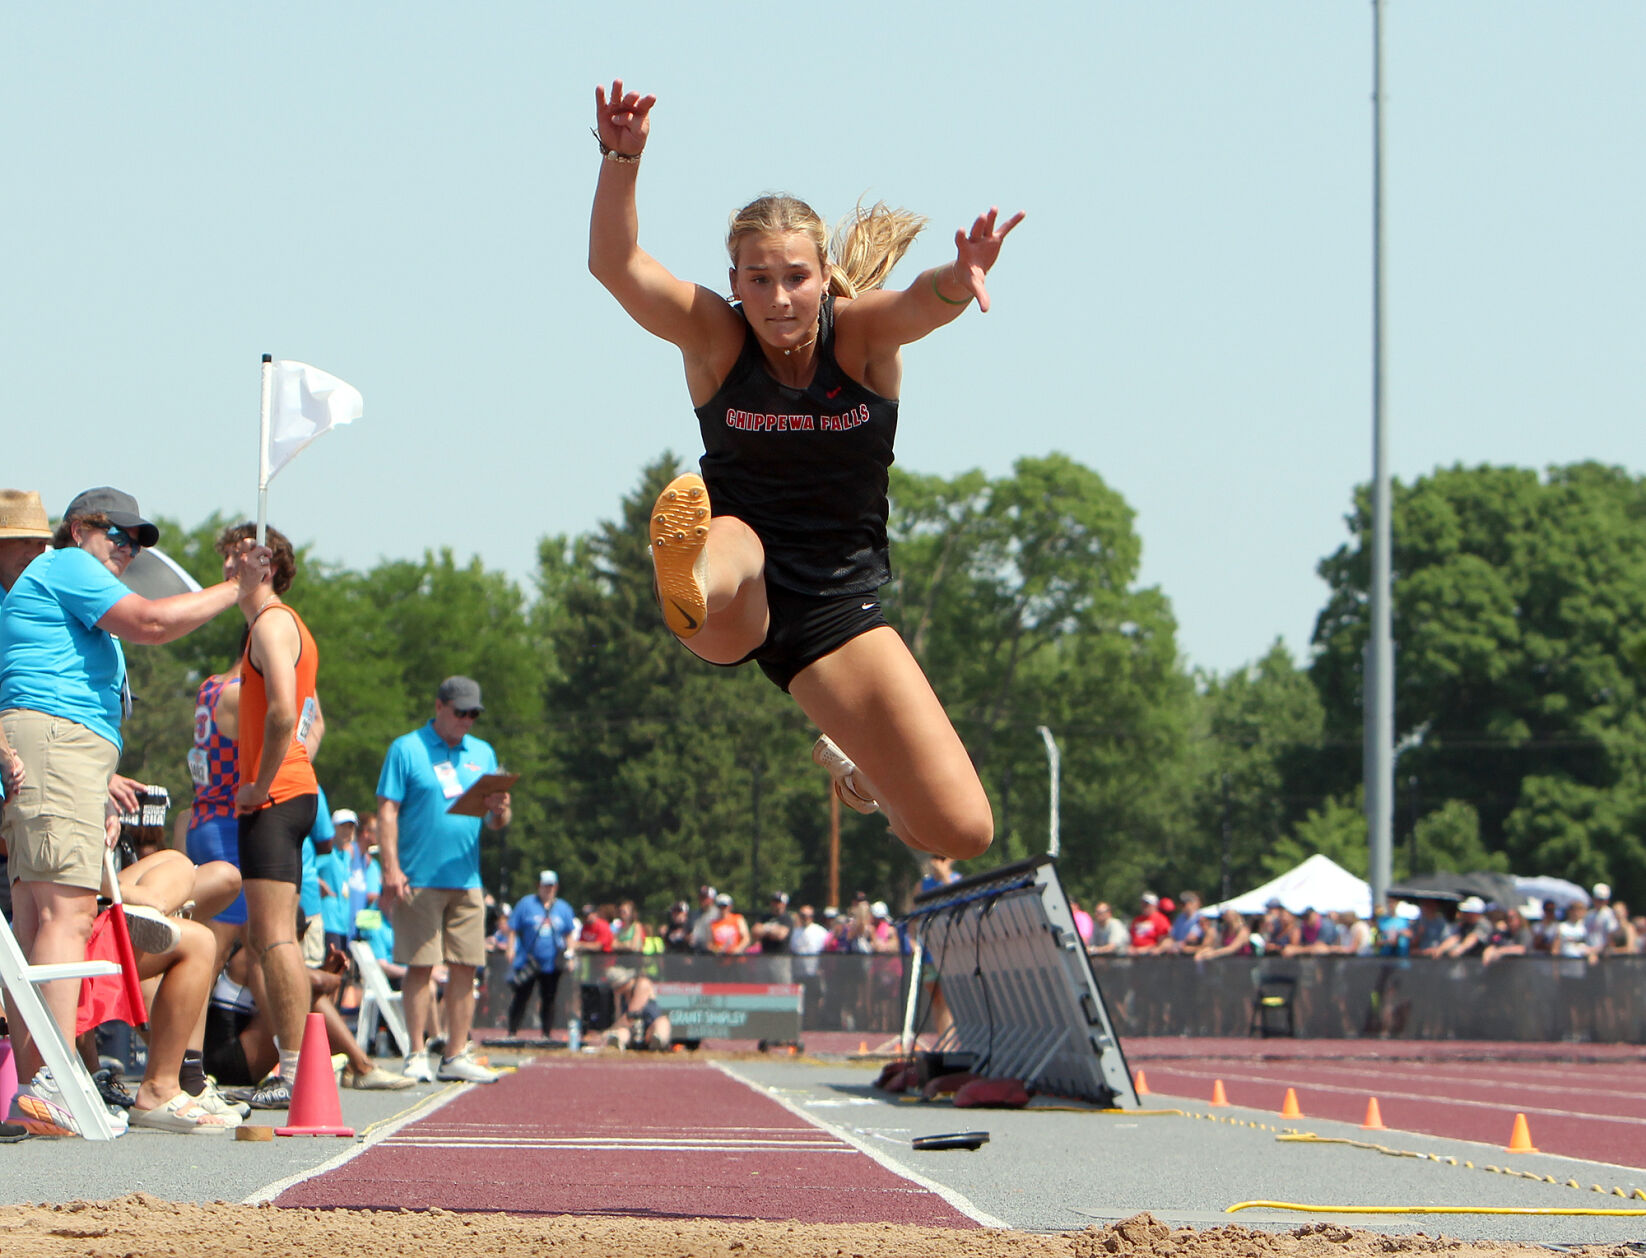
left=377, top=677, right=512, bottom=1083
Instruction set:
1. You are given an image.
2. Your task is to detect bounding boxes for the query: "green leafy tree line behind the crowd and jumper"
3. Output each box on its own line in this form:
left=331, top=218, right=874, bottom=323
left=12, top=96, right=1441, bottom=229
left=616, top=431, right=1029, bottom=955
left=112, top=453, right=1646, bottom=916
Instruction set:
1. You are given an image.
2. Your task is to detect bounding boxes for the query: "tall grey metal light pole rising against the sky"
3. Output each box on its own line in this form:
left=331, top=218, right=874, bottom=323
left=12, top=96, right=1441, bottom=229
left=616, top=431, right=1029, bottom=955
left=1361, top=0, right=1394, bottom=907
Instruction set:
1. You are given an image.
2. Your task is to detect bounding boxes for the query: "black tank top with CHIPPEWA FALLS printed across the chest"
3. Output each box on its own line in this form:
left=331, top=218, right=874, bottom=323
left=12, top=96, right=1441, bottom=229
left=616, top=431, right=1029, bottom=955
left=696, top=296, right=897, bottom=594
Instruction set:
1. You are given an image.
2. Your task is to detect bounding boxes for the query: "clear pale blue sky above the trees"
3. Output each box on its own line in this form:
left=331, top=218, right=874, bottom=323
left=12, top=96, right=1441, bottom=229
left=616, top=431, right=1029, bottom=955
left=0, top=0, right=1646, bottom=672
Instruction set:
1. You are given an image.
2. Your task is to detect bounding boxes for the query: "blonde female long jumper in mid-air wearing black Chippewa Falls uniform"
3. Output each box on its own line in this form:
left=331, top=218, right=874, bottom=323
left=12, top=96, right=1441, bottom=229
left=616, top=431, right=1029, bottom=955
left=589, top=81, right=1022, bottom=860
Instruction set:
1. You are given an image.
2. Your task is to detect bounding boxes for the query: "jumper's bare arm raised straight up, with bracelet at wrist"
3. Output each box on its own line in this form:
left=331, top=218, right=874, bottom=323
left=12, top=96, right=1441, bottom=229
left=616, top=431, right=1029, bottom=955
left=589, top=79, right=736, bottom=359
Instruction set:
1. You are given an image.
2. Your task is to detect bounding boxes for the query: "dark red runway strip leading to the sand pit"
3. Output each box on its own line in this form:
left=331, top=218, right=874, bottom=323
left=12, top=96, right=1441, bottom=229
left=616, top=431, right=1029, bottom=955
left=275, top=1059, right=976, bottom=1228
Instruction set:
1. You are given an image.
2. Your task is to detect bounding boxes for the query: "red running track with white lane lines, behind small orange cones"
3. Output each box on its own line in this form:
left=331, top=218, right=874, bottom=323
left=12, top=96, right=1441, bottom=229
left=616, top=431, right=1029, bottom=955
left=1128, top=1041, right=1646, bottom=1167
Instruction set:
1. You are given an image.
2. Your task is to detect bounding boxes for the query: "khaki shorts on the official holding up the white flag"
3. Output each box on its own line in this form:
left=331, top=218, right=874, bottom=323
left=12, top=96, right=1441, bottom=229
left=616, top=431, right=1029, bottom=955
left=0, top=708, right=120, bottom=891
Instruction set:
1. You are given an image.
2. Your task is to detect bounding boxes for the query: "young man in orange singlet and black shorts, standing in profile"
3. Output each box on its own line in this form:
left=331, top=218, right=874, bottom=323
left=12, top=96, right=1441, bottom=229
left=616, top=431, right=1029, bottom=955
left=217, top=524, right=319, bottom=1110
